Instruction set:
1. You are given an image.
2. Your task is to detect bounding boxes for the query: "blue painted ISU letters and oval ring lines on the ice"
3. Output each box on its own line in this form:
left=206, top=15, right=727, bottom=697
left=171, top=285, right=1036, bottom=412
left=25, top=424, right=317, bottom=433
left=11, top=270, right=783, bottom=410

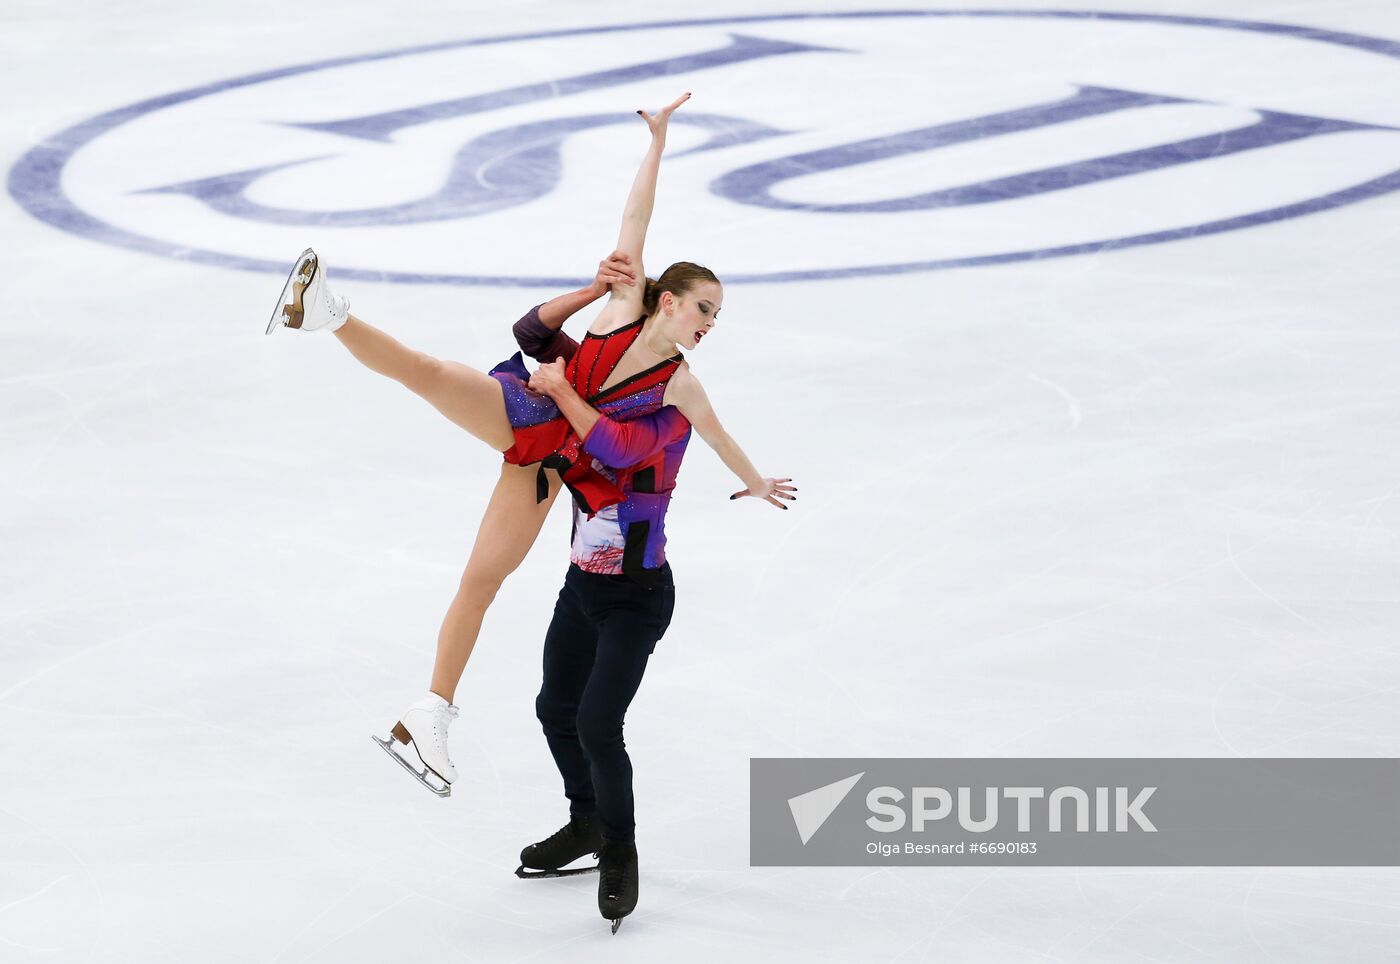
left=8, top=10, right=1400, bottom=287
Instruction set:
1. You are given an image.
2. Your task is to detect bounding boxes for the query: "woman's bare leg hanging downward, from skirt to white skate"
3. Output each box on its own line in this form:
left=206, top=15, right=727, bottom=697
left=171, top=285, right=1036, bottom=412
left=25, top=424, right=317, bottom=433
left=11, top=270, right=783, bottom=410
left=431, top=461, right=560, bottom=702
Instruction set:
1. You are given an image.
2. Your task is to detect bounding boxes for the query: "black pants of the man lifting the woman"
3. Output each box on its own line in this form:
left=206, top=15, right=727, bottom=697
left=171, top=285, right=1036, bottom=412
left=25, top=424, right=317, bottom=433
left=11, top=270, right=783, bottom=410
left=535, top=565, right=676, bottom=841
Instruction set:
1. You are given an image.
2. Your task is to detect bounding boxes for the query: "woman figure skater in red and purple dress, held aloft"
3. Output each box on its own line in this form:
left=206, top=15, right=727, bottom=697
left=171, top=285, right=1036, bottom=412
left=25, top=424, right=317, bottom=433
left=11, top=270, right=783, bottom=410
left=267, top=95, right=795, bottom=817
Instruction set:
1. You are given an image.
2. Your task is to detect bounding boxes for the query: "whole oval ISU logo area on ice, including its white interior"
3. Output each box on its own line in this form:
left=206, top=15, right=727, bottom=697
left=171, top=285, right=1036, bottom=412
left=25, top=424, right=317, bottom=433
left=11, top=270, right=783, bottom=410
left=8, top=10, right=1400, bottom=285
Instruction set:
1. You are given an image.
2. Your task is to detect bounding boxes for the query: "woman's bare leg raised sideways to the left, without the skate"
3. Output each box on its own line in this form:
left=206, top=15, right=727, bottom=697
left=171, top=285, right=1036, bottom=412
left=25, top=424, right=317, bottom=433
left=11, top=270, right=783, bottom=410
left=335, top=315, right=520, bottom=453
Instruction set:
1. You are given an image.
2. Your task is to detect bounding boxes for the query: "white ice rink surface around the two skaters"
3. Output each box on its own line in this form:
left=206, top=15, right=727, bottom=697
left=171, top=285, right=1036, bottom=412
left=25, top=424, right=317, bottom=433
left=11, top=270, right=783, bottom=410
left=0, top=0, right=1400, bottom=964
